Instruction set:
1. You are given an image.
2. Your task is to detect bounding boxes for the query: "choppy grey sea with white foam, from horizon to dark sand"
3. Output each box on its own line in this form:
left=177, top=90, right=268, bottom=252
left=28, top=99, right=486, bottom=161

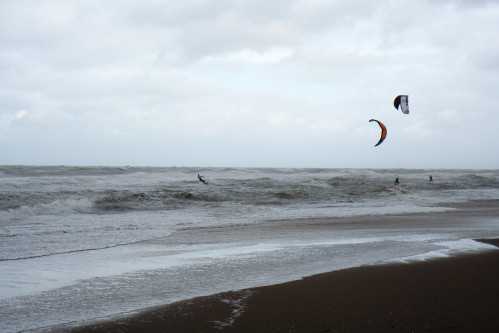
left=0, top=166, right=499, bottom=332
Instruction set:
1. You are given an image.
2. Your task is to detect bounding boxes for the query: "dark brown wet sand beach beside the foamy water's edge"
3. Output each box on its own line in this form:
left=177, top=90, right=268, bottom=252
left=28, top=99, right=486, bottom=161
left=72, top=239, right=499, bottom=332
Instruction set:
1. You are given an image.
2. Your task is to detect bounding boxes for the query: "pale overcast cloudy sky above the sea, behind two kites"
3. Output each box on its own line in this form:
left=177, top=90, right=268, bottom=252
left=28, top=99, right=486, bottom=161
left=0, top=0, right=499, bottom=169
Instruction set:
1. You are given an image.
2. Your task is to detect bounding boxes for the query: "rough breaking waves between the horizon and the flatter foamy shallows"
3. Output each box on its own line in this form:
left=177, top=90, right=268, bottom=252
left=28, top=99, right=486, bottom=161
left=0, top=166, right=499, bottom=221
